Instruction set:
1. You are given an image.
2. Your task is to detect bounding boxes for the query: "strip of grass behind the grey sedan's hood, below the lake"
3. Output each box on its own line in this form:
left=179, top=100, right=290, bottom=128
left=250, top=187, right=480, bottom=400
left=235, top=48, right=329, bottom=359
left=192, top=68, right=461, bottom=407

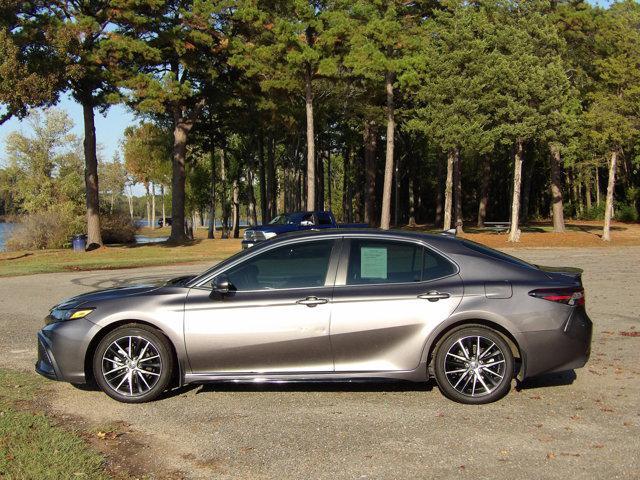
left=0, top=239, right=240, bottom=277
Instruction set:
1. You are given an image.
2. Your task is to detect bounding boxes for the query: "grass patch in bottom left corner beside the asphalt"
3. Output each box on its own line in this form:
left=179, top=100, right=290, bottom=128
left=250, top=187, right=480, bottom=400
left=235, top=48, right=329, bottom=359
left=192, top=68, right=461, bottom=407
left=0, top=369, right=109, bottom=480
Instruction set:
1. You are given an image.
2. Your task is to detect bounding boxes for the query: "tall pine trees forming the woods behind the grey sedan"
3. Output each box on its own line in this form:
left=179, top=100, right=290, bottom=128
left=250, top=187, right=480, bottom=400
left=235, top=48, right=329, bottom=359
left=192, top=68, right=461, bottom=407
left=0, top=0, right=640, bottom=244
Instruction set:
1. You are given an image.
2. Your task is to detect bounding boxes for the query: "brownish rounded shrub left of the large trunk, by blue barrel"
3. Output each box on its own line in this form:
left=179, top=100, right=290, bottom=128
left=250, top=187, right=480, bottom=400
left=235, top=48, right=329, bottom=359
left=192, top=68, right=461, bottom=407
left=6, top=205, right=84, bottom=251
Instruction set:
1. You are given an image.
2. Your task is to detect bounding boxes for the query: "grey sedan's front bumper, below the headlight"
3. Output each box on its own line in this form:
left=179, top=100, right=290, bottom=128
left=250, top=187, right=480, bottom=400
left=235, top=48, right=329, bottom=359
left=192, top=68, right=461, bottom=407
left=35, top=319, right=99, bottom=383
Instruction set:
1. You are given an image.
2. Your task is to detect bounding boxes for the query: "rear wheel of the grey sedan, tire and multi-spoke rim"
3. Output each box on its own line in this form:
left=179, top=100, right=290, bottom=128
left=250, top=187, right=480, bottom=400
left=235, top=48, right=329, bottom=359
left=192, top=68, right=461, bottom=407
left=434, top=325, right=514, bottom=405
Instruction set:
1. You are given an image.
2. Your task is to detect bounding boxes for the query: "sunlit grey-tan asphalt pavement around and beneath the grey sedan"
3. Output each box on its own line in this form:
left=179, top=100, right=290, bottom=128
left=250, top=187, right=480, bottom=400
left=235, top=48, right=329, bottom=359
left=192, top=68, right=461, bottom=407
left=0, top=247, right=640, bottom=480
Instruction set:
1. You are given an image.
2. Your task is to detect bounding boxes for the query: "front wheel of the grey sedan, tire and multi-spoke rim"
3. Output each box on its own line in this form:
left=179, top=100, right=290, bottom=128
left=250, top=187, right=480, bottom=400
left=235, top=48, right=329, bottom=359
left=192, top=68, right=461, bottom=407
left=93, top=323, right=174, bottom=403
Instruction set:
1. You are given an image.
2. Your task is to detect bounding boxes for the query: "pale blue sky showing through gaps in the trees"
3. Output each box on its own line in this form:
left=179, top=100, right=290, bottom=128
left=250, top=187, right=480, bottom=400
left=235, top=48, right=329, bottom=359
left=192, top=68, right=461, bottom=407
left=0, top=0, right=611, bottom=178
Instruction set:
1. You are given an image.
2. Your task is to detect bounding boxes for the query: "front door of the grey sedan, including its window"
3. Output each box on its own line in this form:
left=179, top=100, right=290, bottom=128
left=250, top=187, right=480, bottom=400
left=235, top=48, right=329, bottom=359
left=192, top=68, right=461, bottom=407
left=184, top=239, right=340, bottom=374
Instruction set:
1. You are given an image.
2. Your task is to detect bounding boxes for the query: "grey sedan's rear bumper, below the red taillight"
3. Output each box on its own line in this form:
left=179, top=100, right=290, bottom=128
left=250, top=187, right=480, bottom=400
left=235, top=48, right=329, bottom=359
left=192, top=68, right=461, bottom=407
left=521, top=307, right=593, bottom=377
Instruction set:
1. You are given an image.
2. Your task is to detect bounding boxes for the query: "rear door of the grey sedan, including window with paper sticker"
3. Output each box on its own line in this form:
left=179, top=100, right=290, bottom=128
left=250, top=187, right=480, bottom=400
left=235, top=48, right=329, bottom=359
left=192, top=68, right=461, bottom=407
left=331, top=237, right=463, bottom=372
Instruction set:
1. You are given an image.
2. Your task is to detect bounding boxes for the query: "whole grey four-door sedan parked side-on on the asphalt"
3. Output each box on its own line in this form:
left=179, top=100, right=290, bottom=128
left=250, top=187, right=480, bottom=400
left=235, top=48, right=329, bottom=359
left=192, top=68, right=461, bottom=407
left=36, top=229, right=592, bottom=404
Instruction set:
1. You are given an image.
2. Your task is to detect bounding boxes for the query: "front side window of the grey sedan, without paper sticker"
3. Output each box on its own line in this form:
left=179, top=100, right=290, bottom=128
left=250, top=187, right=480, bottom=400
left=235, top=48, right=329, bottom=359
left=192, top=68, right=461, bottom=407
left=225, top=240, right=334, bottom=291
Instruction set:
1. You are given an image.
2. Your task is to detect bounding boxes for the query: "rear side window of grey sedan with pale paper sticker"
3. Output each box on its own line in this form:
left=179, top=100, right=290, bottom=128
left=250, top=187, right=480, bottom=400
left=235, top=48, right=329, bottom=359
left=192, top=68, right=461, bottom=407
left=347, top=239, right=456, bottom=285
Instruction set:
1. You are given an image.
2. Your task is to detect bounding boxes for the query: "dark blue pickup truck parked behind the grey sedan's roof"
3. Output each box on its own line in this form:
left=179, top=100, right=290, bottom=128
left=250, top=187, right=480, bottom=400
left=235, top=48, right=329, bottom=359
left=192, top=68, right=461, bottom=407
left=242, top=211, right=368, bottom=250
